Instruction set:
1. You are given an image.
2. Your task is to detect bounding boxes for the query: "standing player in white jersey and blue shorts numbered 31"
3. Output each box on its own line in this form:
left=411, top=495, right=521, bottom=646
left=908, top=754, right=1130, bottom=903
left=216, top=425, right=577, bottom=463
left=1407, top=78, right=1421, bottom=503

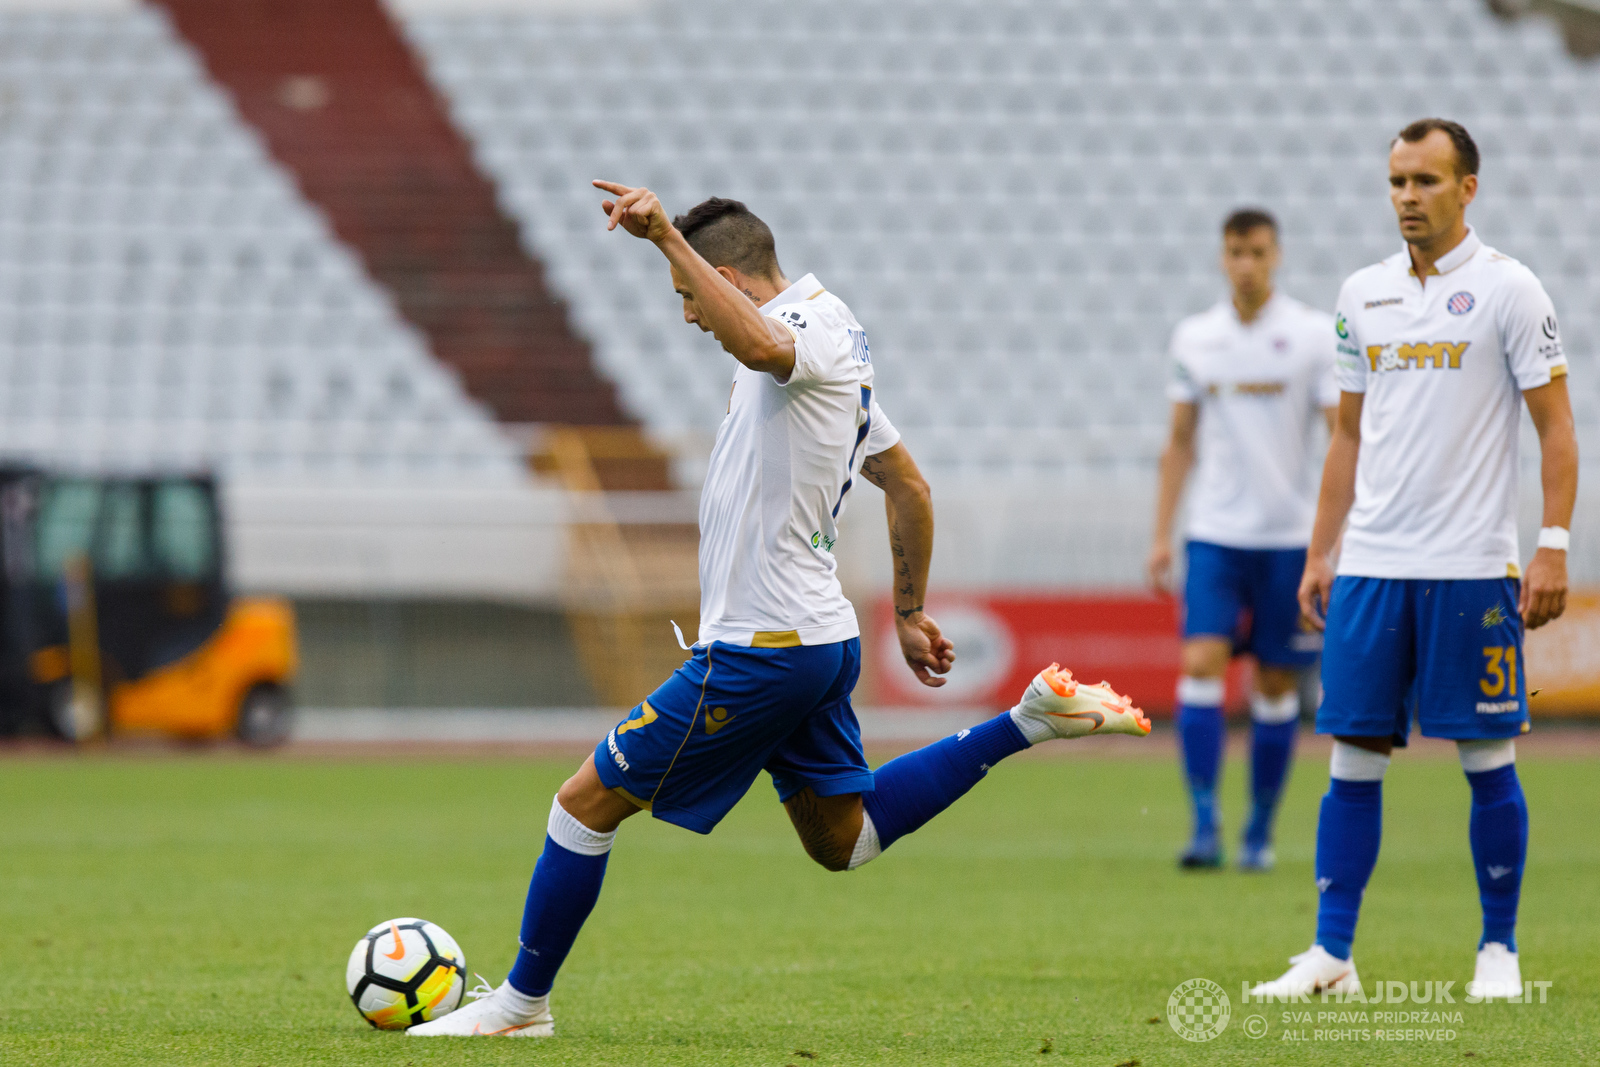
left=1254, top=118, right=1578, bottom=997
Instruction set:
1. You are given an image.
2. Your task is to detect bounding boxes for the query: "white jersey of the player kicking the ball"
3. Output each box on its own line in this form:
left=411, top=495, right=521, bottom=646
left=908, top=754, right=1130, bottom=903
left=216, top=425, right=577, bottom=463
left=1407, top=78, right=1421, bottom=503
left=699, top=274, right=899, bottom=646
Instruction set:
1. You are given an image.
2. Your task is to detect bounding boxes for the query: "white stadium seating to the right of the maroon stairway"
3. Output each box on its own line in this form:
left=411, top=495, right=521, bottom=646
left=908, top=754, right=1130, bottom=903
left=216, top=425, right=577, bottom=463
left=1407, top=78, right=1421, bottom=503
left=400, top=0, right=1600, bottom=479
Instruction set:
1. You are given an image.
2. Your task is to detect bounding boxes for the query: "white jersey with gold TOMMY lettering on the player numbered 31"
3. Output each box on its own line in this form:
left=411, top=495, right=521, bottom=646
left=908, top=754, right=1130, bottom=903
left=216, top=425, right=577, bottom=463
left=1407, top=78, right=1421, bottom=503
left=1336, top=223, right=1566, bottom=579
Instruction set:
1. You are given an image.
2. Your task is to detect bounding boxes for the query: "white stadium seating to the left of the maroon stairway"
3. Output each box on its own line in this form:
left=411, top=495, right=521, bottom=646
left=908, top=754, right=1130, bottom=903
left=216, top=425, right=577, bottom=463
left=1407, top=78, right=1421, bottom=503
left=0, top=5, right=525, bottom=486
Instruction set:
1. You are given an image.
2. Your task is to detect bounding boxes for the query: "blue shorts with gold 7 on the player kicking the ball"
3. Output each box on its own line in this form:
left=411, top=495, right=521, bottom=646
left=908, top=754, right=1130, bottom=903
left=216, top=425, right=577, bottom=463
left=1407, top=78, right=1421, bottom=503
left=595, top=638, right=872, bottom=833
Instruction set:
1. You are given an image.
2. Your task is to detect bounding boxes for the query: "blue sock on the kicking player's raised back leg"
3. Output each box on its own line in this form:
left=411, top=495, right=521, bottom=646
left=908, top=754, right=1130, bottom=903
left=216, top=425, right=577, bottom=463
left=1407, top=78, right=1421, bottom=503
left=861, top=712, right=1027, bottom=848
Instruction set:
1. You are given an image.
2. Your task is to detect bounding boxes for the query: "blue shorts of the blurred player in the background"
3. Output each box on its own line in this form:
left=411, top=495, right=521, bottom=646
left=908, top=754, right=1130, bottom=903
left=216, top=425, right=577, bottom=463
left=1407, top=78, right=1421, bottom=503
left=1184, top=541, right=1322, bottom=667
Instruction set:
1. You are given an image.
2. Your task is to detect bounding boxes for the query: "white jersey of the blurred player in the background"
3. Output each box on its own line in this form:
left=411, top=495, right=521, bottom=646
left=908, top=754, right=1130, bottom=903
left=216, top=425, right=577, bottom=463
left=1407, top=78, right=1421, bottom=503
left=1166, top=294, right=1339, bottom=549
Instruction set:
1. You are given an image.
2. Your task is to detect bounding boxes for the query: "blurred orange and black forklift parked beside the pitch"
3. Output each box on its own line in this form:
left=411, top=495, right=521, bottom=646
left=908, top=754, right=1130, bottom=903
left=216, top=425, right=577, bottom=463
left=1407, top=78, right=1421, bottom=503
left=0, top=470, right=296, bottom=745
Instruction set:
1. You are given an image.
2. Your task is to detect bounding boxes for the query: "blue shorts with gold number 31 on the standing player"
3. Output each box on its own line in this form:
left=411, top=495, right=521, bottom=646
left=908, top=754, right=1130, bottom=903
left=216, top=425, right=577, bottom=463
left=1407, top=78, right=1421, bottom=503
left=1317, top=576, right=1528, bottom=745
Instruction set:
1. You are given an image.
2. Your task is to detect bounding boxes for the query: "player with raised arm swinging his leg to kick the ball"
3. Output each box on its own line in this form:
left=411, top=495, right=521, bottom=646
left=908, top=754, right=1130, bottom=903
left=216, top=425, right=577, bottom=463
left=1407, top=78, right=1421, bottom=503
left=410, top=182, right=1150, bottom=1037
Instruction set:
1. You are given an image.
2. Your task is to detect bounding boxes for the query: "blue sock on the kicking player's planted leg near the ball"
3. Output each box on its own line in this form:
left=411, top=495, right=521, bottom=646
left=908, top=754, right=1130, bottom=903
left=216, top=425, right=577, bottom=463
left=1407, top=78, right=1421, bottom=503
left=506, top=835, right=611, bottom=997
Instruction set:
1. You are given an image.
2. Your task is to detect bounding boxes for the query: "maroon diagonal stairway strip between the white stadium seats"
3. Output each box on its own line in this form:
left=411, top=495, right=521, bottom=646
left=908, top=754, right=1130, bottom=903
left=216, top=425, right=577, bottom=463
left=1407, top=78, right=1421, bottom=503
left=154, top=0, right=630, bottom=426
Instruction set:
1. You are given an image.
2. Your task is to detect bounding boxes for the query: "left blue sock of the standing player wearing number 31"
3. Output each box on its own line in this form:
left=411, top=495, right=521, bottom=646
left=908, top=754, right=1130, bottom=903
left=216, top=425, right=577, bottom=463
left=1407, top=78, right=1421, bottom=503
left=1317, top=777, right=1384, bottom=960
